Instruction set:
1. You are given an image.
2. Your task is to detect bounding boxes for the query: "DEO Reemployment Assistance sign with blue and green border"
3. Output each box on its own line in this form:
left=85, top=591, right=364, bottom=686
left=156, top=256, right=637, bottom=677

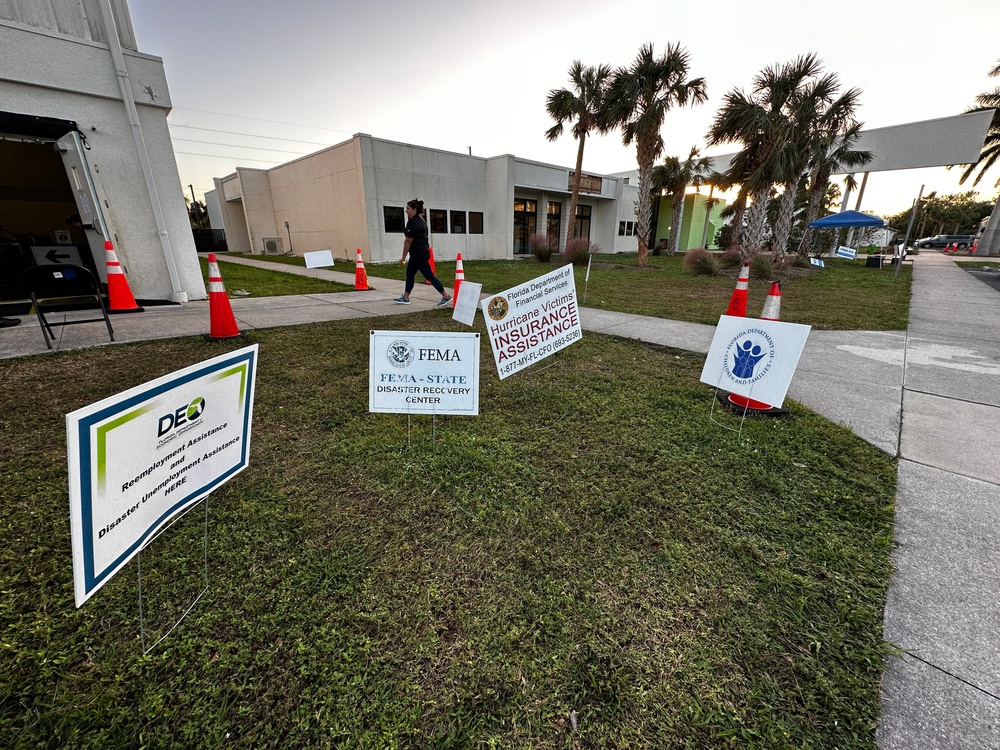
left=66, top=345, right=257, bottom=607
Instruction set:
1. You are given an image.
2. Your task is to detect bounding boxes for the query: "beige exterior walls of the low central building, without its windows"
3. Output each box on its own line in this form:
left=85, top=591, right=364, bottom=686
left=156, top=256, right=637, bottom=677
left=216, top=134, right=622, bottom=263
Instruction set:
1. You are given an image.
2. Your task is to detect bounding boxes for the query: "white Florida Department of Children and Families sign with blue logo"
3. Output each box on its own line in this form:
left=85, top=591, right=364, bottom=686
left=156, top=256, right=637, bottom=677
left=701, top=315, right=810, bottom=407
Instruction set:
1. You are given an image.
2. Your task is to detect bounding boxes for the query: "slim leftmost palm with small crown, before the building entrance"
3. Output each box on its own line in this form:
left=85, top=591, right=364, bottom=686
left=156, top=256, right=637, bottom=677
left=545, top=60, right=611, bottom=250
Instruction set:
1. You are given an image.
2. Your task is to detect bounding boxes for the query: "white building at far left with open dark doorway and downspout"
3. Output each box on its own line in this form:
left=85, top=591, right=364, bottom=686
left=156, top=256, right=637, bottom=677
left=0, top=0, right=206, bottom=302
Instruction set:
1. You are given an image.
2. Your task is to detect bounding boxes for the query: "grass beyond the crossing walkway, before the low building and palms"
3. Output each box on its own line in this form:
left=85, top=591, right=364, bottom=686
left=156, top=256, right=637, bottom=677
left=222, top=255, right=913, bottom=331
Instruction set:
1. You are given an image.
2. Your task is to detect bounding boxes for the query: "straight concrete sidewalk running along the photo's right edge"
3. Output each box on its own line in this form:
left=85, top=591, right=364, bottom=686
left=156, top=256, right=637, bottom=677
left=878, top=251, right=1000, bottom=750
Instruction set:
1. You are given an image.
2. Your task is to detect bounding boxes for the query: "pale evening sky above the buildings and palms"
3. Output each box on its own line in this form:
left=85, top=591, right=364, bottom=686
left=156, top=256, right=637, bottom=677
left=129, top=0, right=1000, bottom=215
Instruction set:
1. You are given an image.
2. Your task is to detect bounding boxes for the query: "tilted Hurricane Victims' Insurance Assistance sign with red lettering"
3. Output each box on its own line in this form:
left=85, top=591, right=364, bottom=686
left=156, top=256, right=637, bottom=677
left=482, top=264, right=583, bottom=380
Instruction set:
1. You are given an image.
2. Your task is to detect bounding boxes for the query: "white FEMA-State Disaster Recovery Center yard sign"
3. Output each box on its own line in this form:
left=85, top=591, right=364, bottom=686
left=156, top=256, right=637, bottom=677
left=368, top=331, right=479, bottom=416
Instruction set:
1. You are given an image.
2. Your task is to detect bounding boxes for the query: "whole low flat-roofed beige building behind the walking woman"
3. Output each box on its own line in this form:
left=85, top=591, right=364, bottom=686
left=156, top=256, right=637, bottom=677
left=206, top=134, right=637, bottom=263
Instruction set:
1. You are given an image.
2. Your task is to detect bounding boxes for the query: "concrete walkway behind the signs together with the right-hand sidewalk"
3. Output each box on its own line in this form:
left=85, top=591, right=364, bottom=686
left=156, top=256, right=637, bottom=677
left=0, top=252, right=1000, bottom=750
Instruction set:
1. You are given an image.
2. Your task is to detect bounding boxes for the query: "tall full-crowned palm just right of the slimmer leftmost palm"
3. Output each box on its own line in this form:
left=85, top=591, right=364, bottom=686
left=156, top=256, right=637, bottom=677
left=602, top=44, right=708, bottom=268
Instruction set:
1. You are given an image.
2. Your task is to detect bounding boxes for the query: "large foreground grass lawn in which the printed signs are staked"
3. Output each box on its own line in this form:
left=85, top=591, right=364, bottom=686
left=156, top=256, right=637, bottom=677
left=0, top=314, right=895, bottom=750
